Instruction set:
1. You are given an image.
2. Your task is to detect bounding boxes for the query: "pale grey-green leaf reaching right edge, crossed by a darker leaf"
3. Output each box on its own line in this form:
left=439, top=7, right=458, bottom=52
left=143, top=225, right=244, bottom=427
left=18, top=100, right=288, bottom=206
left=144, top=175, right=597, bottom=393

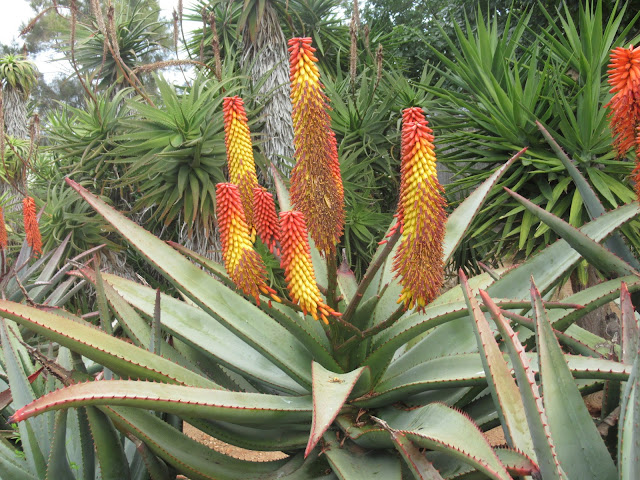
left=487, top=203, right=640, bottom=299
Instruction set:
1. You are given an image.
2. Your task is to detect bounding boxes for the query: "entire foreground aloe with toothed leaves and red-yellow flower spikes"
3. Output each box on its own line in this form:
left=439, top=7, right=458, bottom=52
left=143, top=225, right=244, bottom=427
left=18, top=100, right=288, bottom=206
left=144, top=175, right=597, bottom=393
left=0, top=34, right=640, bottom=479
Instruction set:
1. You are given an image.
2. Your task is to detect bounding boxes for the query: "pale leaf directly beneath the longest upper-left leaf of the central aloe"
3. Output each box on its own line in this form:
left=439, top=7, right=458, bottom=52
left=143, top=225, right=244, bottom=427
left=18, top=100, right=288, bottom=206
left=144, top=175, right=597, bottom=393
left=104, top=274, right=305, bottom=393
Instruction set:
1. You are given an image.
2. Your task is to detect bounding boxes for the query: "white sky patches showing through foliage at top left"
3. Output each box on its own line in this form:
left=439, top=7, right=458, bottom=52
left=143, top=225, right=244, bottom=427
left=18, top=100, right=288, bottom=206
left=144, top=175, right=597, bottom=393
left=0, top=0, right=194, bottom=76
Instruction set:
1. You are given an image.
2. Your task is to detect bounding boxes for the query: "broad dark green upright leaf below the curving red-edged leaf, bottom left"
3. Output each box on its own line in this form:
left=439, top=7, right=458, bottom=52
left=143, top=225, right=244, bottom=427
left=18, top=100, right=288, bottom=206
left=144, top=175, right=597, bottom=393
left=85, top=407, right=131, bottom=480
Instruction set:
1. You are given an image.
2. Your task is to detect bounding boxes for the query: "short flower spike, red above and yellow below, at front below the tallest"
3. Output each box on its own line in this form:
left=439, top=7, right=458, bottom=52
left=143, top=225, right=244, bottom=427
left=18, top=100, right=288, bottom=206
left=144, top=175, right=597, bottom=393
left=280, top=211, right=340, bottom=324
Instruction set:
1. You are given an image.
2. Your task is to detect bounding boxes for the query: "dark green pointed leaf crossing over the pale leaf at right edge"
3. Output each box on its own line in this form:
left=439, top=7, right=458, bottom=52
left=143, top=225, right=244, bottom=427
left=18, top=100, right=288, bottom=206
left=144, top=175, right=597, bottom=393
left=505, top=188, right=638, bottom=278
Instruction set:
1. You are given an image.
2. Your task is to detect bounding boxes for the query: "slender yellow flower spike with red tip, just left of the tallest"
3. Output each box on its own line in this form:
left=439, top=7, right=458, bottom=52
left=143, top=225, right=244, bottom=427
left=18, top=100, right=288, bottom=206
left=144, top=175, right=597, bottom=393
left=222, top=97, right=258, bottom=229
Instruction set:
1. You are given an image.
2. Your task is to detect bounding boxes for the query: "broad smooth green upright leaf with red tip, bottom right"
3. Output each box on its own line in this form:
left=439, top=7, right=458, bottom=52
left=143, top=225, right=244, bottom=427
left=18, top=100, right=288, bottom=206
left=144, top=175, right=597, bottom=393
left=531, top=282, right=617, bottom=480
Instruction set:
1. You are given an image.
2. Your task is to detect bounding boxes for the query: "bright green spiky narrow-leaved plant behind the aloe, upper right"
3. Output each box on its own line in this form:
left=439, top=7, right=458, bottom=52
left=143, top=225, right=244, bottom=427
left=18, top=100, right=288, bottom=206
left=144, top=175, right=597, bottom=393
left=425, top=1, right=639, bottom=278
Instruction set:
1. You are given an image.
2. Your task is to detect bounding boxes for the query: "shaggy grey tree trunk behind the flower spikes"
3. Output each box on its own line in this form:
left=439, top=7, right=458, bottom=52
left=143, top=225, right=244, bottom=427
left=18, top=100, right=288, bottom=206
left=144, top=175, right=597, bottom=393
left=243, top=2, right=294, bottom=178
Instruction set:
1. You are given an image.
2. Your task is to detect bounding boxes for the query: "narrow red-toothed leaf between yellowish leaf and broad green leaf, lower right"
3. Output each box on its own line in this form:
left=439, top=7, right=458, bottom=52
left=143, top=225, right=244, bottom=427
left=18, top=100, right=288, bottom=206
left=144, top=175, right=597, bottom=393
left=480, top=290, right=567, bottom=480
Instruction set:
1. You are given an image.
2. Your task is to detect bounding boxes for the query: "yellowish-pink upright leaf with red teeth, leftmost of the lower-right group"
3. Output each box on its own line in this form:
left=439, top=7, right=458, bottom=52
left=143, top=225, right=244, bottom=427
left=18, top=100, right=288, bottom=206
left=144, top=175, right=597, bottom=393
left=459, top=270, right=535, bottom=458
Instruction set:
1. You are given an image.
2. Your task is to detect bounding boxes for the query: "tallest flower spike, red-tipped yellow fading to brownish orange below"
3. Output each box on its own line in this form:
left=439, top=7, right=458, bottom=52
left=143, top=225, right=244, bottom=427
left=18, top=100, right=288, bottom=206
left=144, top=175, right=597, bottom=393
left=289, top=38, right=345, bottom=255
